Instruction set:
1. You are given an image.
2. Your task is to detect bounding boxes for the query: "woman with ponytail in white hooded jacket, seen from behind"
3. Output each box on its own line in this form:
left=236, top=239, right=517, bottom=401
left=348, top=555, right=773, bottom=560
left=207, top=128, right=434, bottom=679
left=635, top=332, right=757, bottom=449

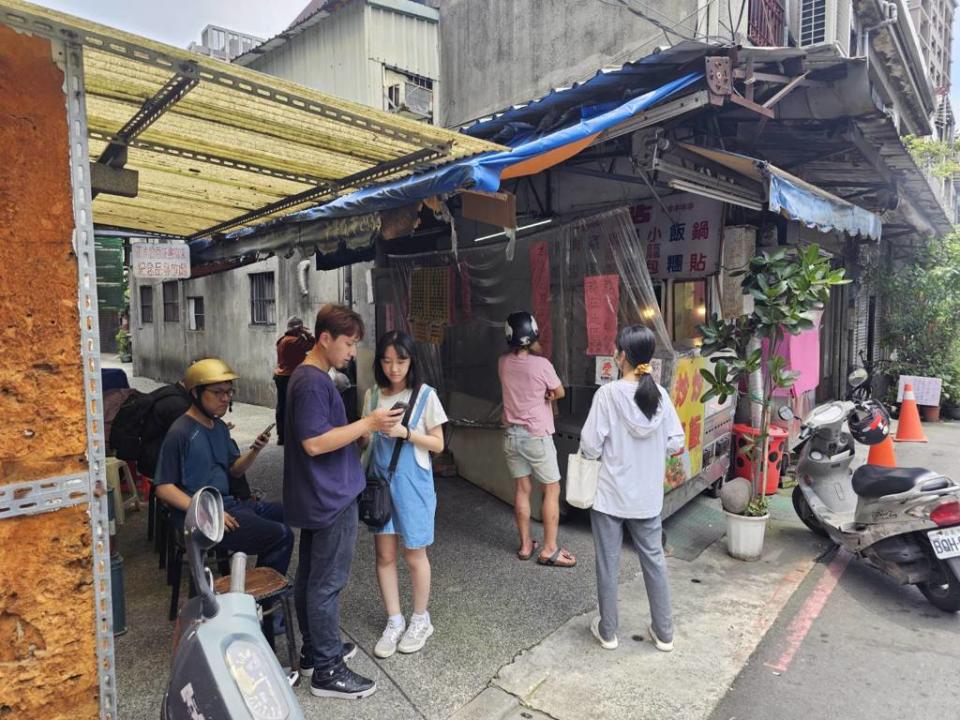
left=580, top=325, right=684, bottom=652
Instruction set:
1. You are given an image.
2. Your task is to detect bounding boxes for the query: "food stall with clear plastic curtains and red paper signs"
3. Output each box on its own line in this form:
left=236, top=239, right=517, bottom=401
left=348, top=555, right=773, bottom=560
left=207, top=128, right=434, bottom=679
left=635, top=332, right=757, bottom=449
left=376, top=202, right=733, bottom=515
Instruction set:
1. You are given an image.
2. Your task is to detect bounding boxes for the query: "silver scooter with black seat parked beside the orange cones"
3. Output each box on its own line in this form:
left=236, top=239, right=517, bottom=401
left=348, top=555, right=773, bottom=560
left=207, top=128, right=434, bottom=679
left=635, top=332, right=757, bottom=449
left=793, top=370, right=960, bottom=612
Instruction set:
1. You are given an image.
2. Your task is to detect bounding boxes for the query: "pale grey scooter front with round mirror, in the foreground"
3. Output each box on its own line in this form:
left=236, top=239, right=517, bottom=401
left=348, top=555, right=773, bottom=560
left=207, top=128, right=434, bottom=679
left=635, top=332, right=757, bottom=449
left=160, top=487, right=303, bottom=720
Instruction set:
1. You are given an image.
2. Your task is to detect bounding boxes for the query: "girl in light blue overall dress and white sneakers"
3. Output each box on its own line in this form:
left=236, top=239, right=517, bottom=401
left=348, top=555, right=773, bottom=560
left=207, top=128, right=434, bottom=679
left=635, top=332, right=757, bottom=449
left=363, top=331, right=447, bottom=658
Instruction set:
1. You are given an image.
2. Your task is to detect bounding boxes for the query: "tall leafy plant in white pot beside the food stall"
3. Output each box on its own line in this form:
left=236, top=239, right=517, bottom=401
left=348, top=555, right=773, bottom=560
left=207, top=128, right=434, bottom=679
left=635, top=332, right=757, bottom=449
left=700, top=245, right=849, bottom=560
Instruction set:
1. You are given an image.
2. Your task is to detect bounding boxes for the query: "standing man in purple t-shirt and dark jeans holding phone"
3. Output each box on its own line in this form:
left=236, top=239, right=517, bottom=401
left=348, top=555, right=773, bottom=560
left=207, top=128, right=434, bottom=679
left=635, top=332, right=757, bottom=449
left=283, top=305, right=403, bottom=698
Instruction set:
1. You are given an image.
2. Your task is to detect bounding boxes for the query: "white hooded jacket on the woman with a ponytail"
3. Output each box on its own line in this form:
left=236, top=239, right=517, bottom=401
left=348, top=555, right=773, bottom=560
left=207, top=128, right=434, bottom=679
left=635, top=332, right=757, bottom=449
left=580, top=380, right=686, bottom=518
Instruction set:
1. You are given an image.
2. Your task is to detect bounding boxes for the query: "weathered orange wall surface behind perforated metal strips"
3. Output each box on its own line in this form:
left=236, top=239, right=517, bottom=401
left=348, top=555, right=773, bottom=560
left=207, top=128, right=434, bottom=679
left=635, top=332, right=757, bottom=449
left=0, top=25, right=99, bottom=720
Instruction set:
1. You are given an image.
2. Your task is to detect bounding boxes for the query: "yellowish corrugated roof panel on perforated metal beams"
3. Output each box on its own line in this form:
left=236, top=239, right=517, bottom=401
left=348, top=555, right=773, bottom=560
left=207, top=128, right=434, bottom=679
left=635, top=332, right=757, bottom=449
left=0, top=0, right=501, bottom=236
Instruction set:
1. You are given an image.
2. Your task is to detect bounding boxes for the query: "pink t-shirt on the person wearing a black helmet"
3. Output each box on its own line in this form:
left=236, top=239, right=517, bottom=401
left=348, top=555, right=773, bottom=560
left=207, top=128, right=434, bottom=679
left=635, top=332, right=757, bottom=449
left=499, top=353, right=563, bottom=437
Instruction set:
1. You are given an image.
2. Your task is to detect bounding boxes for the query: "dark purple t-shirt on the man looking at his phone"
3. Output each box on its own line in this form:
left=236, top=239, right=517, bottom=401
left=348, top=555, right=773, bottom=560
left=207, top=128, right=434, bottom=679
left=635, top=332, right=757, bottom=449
left=283, top=365, right=365, bottom=530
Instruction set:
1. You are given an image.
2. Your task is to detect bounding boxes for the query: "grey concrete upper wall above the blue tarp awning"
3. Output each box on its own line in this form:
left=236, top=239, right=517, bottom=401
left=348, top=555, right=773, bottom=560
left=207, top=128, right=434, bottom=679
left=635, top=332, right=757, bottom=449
left=429, top=0, right=697, bottom=127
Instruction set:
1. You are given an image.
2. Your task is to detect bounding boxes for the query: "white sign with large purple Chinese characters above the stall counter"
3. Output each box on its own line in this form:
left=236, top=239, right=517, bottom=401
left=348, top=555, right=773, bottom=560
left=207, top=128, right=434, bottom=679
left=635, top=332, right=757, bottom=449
left=630, top=193, right=723, bottom=280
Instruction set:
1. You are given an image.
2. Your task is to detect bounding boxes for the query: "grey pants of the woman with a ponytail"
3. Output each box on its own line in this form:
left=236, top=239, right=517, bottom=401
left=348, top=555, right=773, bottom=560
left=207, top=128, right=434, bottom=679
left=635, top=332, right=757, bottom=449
left=590, top=510, right=673, bottom=642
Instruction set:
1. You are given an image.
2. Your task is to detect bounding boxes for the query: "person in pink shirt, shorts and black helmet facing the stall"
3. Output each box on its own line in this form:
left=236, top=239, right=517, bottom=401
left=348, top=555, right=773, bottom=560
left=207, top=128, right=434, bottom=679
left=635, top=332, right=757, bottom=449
left=498, top=312, right=577, bottom=567
